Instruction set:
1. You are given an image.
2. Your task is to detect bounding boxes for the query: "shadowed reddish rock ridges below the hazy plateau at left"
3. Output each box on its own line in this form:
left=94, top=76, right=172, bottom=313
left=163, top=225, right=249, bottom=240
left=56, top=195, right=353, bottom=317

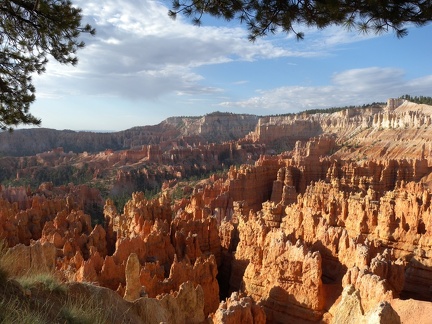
left=0, top=135, right=266, bottom=200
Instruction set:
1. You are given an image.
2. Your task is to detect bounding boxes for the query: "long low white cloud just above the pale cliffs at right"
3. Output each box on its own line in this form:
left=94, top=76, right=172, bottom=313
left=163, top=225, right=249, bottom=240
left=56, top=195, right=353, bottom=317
left=219, top=67, right=432, bottom=113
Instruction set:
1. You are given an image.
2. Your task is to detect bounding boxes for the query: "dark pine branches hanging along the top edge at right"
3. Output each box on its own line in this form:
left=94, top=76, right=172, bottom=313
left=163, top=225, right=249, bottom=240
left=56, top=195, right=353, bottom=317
left=168, top=0, right=432, bottom=41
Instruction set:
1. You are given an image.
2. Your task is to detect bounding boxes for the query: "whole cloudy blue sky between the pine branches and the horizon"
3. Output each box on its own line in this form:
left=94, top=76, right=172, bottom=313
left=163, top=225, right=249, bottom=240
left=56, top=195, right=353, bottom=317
left=25, top=0, right=432, bottom=131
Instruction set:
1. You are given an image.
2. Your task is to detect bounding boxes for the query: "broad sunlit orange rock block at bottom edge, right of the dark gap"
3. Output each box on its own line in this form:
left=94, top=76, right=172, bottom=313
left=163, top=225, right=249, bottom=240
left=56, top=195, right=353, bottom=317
left=231, top=216, right=324, bottom=323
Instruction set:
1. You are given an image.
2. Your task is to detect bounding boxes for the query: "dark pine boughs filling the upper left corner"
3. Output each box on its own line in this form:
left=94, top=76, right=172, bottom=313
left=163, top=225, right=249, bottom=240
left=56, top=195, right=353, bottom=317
left=0, top=0, right=94, bottom=130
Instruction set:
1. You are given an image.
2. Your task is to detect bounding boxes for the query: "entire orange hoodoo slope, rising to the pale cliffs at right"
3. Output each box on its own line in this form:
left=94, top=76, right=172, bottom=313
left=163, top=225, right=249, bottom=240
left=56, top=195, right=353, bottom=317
left=0, top=100, right=432, bottom=323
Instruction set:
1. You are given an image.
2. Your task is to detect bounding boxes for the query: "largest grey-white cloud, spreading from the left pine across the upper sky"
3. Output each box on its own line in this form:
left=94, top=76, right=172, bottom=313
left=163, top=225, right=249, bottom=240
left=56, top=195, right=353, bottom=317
left=35, top=0, right=348, bottom=99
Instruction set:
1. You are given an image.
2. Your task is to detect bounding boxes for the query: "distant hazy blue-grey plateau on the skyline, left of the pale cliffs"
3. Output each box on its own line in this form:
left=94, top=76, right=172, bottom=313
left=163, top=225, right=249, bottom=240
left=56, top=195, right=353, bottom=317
left=0, top=112, right=258, bottom=156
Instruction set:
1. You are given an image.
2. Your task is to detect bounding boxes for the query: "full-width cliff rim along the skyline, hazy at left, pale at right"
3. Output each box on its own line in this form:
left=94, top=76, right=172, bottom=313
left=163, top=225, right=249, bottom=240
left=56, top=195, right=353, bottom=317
left=0, top=99, right=432, bottom=158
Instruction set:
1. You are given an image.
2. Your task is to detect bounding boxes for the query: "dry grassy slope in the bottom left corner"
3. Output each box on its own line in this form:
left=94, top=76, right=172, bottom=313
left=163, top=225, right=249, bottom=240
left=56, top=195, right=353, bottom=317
left=0, top=240, right=123, bottom=324
